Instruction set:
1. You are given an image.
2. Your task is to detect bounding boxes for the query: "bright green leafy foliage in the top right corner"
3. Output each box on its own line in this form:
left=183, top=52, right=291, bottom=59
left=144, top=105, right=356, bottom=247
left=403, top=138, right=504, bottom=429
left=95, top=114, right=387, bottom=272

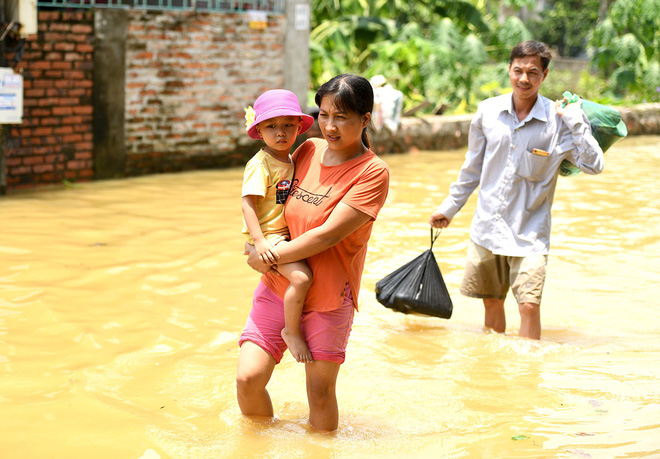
left=590, top=0, right=660, bottom=101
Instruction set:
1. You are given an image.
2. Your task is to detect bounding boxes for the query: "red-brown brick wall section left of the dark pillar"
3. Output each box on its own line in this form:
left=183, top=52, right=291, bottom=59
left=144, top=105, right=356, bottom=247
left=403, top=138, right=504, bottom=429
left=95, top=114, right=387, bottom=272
left=6, top=11, right=93, bottom=188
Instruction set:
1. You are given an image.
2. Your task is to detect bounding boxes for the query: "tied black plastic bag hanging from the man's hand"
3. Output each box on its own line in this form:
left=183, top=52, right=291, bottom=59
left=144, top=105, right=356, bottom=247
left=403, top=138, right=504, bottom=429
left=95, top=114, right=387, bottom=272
left=376, top=229, right=454, bottom=319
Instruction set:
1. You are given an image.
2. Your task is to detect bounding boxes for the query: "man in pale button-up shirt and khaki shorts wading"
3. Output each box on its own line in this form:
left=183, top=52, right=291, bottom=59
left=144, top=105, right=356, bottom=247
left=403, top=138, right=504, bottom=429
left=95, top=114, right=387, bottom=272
left=430, top=41, right=603, bottom=339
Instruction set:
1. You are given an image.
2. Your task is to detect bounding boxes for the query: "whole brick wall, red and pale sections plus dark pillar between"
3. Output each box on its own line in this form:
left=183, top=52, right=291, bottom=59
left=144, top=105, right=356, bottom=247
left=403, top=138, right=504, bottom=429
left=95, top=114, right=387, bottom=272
left=6, top=7, right=288, bottom=189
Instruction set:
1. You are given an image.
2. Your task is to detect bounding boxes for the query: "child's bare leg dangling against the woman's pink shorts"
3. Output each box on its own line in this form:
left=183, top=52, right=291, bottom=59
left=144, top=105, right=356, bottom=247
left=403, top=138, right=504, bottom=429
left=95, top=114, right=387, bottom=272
left=277, top=261, right=312, bottom=363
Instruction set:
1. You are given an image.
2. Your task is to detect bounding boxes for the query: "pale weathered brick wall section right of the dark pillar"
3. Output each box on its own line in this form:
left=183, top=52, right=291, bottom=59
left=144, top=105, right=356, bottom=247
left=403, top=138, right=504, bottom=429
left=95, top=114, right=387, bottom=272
left=126, top=11, right=286, bottom=175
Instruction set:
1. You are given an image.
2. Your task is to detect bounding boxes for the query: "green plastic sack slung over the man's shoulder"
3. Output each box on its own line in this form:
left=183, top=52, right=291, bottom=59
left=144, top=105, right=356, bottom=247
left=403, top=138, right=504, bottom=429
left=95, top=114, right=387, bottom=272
left=559, top=91, right=628, bottom=177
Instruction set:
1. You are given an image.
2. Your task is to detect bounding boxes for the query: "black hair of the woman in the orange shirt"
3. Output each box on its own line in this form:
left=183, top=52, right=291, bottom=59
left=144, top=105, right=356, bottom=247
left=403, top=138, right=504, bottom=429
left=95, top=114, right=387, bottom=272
left=314, top=73, right=374, bottom=148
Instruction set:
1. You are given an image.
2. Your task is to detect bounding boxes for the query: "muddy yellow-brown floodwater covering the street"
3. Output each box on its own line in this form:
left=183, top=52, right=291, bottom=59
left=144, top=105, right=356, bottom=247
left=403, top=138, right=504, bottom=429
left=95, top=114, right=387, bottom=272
left=0, top=137, right=660, bottom=458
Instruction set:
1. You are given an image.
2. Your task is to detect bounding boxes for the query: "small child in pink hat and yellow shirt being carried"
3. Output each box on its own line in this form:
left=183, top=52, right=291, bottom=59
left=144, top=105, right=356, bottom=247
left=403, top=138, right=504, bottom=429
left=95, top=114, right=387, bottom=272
left=241, top=89, right=314, bottom=363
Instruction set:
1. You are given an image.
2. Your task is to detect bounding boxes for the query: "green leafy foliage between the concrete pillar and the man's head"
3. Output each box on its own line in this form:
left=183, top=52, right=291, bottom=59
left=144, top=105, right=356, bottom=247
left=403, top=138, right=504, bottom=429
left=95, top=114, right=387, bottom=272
left=310, top=0, right=531, bottom=112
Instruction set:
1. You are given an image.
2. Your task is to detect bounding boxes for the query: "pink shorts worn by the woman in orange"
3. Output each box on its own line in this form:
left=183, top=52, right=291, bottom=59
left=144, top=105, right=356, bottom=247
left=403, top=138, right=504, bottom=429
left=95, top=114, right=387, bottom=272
left=238, top=282, right=355, bottom=364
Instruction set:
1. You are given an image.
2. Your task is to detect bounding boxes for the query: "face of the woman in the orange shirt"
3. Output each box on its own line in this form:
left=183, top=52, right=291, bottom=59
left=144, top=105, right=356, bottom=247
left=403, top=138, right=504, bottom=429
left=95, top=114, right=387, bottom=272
left=319, top=95, right=371, bottom=154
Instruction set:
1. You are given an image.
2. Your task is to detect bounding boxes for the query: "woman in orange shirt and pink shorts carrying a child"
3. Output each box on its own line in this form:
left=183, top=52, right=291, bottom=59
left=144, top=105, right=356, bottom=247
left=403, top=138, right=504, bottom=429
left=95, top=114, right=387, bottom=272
left=236, top=74, right=390, bottom=431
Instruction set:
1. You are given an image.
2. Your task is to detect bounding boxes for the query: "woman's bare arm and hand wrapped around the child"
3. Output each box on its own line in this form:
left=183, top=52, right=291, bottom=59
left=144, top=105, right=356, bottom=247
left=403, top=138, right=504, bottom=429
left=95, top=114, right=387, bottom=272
left=247, top=202, right=371, bottom=272
